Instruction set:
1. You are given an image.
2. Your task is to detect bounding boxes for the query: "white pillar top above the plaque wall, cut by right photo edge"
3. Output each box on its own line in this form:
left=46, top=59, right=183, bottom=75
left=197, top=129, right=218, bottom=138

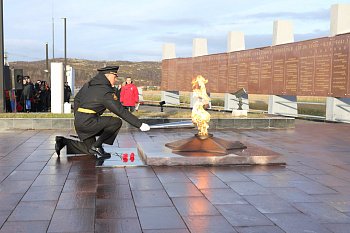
left=330, top=4, right=350, bottom=36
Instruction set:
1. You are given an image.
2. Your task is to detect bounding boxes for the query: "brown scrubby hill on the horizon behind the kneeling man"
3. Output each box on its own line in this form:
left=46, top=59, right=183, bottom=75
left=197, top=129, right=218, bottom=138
left=9, top=59, right=161, bottom=86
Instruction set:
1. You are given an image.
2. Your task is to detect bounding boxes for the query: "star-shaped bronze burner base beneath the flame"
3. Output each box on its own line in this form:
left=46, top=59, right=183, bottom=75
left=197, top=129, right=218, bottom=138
left=165, top=134, right=247, bottom=156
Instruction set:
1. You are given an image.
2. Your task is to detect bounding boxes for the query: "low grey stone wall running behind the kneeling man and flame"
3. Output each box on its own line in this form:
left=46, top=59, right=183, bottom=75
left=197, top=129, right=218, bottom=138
left=0, top=117, right=295, bottom=129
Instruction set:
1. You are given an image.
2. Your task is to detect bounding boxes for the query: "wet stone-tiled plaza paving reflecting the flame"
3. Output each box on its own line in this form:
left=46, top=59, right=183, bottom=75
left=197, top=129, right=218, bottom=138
left=0, top=121, right=350, bottom=233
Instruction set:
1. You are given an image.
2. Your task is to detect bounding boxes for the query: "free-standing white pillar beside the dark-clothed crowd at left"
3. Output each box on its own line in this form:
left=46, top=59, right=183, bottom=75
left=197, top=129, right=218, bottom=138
left=51, top=62, right=64, bottom=113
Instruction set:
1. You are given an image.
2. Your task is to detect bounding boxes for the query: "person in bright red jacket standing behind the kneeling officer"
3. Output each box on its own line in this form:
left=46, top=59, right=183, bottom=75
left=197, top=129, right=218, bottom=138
left=120, top=77, right=139, bottom=112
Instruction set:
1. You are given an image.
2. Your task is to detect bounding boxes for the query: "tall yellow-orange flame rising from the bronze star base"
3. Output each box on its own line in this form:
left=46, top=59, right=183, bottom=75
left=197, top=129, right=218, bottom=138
left=192, top=75, right=210, bottom=136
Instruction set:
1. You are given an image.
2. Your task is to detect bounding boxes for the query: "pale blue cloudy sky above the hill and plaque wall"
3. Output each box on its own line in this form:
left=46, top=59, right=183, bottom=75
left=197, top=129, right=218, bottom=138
left=3, top=0, right=350, bottom=61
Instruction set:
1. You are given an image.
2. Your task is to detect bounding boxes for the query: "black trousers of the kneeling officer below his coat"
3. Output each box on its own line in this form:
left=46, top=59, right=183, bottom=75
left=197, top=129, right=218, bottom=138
left=63, top=117, right=122, bottom=154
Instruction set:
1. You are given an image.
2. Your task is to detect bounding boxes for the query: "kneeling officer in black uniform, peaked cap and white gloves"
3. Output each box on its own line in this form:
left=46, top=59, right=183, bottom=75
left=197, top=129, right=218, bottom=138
left=55, top=66, right=150, bottom=158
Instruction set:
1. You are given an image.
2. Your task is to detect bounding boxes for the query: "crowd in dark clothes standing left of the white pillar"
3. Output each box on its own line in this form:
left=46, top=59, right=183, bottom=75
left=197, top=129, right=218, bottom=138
left=6, top=76, right=51, bottom=112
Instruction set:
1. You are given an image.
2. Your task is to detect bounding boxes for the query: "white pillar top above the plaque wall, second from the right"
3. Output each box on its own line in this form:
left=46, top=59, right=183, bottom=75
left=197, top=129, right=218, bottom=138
left=272, top=20, right=294, bottom=45
